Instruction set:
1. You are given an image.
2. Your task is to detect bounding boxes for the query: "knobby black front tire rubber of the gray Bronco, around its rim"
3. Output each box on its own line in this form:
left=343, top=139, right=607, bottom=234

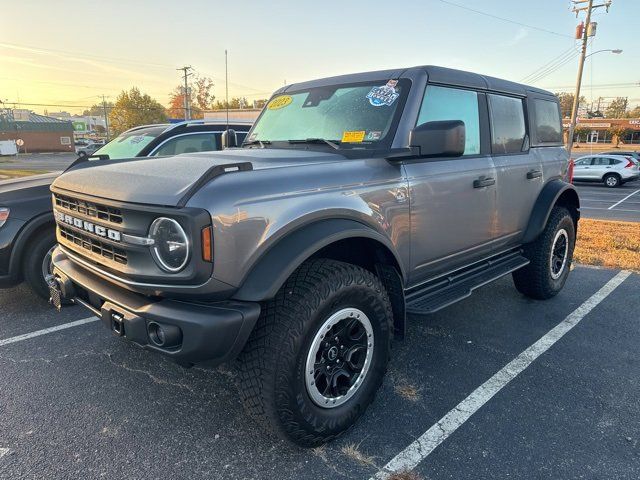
left=238, top=259, right=393, bottom=447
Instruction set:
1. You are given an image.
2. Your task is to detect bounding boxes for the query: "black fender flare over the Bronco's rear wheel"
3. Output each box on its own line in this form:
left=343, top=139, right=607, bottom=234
left=522, top=179, right=580, bottom=243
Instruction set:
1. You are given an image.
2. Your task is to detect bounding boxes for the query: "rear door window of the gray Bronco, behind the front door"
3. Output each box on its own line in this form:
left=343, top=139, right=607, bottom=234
left=489, top=94, right=527, bottom=154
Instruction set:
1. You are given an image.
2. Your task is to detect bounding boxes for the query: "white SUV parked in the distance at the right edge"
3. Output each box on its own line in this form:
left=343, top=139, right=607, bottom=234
left=573, top=155, right=640, bottom=188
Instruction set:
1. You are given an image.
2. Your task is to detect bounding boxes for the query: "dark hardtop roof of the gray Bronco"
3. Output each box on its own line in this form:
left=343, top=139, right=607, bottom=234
left=284, top=65, right=554, bottom=97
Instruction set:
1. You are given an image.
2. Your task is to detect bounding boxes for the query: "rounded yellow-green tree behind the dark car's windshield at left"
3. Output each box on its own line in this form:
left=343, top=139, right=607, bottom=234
left=109, top=87, right=167, bottom=135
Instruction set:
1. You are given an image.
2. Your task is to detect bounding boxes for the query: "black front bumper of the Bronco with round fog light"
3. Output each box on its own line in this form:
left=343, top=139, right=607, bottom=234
left=50, top=248, right=260, bottom=366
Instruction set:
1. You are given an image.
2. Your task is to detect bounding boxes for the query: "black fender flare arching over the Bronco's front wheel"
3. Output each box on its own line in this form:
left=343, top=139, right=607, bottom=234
left=233, top=218, right=404, bottom=302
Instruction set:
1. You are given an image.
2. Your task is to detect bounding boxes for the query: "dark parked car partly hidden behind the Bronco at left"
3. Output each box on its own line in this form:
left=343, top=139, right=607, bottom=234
left=0, top=120, right=251, bottom=298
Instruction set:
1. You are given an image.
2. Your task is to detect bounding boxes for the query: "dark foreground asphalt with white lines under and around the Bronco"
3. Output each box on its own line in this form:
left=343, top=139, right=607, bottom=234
left=0, top=267, right=640, bottom=480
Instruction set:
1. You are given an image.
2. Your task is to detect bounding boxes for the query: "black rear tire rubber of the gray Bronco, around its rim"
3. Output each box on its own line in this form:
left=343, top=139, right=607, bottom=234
left=513, top=207, right=576, bottom=300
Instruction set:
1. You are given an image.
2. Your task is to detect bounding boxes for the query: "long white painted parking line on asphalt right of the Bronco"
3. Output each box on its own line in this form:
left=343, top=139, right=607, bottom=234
left=370, top=270, right=631, bottom=480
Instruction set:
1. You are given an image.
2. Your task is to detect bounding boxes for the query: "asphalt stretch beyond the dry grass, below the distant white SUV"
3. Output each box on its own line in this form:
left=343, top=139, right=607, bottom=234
left=575, top=181, right=640, bottom=222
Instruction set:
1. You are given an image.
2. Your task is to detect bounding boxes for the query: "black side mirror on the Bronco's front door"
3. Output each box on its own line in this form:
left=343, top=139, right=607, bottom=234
left=409, top=120, right=465, bottom=157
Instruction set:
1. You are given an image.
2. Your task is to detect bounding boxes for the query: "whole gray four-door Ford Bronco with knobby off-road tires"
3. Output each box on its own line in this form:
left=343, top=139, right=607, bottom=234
left=49, top=66, right=580, bottom=446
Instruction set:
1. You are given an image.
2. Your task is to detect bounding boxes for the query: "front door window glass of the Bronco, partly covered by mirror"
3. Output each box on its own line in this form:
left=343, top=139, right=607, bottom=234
left=417, top=85, right=480, bottom=155
